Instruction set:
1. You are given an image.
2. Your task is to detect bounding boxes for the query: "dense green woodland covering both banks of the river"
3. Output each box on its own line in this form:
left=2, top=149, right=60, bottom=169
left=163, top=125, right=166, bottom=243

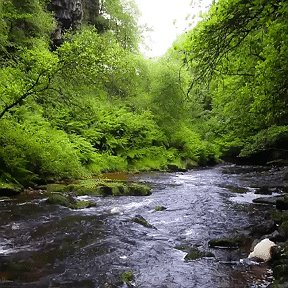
left=0, top=0, right=288, bottom=186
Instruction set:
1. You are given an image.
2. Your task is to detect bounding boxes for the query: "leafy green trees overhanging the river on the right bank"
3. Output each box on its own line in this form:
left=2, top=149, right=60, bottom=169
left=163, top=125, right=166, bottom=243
left=175, top=0, right=288, bottom=159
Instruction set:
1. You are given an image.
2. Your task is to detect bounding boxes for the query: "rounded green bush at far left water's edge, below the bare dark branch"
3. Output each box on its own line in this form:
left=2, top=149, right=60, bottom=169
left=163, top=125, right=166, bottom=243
left=0, top=114, right=85, bottom=184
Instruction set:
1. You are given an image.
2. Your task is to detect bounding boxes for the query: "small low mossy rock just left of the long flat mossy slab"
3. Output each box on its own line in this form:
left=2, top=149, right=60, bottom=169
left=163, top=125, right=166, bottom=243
left=46, top=193, right=95, bottom=209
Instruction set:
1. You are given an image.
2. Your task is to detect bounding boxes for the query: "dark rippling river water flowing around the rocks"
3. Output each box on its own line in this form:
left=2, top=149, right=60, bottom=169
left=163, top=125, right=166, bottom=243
left=0, top=166, right=283, bottom=288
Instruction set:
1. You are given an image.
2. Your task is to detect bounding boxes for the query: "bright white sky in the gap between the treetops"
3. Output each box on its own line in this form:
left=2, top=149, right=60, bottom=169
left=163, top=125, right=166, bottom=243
left=135, top=0, right=212, bottom=57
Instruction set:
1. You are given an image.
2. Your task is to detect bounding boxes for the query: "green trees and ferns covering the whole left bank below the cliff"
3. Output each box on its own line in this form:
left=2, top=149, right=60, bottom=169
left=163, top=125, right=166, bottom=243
left=0, top=0, right=223, bottom=188
